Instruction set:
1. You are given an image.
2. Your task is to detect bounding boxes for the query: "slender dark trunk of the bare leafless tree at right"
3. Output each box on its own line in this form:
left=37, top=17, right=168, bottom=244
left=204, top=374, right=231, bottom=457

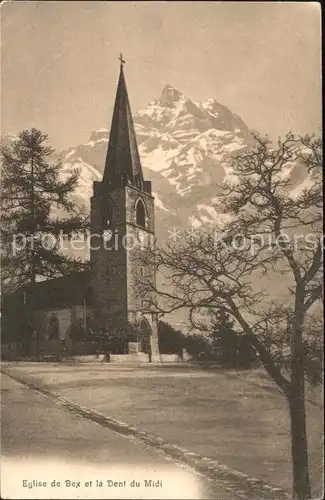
left=289, top=283, right=311, bottom=500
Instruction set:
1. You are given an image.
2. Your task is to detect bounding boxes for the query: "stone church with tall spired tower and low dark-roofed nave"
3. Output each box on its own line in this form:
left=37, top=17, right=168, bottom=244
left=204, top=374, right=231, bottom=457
left=2, top=57, right=159, bottom=360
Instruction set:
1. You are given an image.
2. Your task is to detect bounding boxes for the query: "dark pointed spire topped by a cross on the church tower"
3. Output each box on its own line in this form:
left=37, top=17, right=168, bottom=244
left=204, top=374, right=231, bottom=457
left=103, top=54, right=143, bottom=188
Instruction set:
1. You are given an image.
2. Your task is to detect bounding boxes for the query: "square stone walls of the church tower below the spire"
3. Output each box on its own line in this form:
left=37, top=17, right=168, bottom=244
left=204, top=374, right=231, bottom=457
left=91, top=183, right=158, bottom=350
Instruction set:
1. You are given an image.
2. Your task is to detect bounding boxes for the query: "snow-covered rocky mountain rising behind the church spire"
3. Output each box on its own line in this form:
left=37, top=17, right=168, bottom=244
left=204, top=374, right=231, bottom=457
left=61, top=85, right=256, bottom=236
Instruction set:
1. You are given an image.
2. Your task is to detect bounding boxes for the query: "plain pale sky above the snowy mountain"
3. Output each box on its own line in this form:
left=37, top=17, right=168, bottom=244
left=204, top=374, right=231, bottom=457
left=1, top=1, right=321, bottom=151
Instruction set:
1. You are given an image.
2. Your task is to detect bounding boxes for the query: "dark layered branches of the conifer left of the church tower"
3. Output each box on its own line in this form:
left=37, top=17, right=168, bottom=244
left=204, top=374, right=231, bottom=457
left=1, top=128, right=88, bottom=290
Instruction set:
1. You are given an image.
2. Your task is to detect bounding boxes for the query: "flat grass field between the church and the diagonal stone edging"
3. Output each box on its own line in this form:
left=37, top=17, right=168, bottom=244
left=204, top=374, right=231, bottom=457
left=1, top=363, right=323, bottom=498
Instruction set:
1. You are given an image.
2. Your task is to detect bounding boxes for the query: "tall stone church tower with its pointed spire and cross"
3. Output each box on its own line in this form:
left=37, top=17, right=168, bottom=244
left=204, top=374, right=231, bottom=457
left=90, top=57, right=159, bottom=359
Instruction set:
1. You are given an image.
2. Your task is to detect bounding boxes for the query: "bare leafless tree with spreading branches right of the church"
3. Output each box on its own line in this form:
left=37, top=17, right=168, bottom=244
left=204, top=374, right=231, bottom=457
left=139, top=133, right=322, bottom=500
